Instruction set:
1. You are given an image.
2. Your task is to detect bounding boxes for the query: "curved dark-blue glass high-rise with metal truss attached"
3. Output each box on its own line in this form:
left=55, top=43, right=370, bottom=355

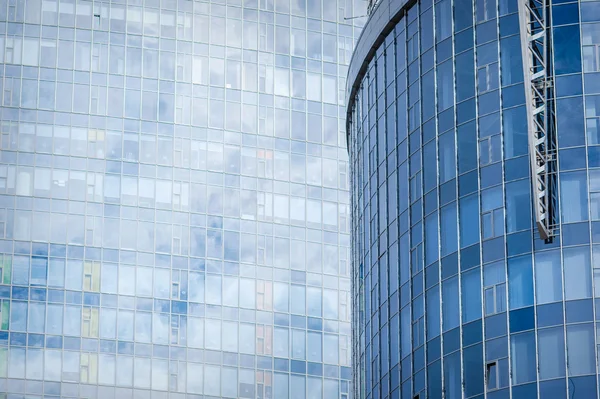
left=347, top=0, right=600, bottom=399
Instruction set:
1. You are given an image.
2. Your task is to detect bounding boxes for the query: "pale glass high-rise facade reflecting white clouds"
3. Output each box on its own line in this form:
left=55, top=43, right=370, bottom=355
left=0, top=0, right=366, bottom=399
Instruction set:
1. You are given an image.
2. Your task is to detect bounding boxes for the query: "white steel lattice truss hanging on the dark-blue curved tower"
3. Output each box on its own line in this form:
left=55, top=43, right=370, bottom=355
left=518, top=0, right=557, bottom=240
